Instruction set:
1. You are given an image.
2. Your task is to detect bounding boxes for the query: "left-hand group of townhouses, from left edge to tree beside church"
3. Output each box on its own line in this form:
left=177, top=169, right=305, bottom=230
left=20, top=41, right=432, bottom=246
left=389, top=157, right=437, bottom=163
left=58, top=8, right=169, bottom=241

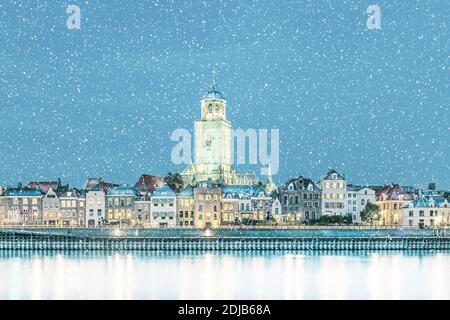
left=0, top=175, right=163, bottom=227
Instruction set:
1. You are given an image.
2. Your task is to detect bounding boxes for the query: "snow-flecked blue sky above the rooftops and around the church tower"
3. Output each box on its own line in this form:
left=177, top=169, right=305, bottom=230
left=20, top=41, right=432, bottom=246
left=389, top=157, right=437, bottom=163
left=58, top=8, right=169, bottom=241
left=0, top=0, right=450, bottom=189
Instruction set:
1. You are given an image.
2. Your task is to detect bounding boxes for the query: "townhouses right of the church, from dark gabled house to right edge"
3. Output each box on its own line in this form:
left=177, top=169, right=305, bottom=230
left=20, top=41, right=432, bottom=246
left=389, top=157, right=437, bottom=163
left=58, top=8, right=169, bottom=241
left=278, top=170, right=450, bottom=227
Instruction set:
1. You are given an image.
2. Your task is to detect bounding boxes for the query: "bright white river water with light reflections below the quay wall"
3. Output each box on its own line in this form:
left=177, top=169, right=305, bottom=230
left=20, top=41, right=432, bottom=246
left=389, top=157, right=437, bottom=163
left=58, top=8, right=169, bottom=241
left=0, top=251, right=450, bottom=299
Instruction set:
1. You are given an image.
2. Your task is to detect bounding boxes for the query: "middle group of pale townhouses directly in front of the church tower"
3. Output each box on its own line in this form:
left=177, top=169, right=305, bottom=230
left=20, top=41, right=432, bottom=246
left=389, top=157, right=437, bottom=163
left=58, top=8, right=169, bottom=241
left=150, top=181, right=279, bottom=228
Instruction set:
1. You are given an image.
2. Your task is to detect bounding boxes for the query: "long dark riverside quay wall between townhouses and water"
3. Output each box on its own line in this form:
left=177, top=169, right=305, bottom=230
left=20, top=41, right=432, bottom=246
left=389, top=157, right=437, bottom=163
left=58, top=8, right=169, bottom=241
left=0, top=228, right=450, bottom=251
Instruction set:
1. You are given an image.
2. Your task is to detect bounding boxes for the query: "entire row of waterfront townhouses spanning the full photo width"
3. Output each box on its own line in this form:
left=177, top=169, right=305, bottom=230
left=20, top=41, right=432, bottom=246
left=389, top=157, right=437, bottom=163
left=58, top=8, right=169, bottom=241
left=0, top=170, right=450, bottom=228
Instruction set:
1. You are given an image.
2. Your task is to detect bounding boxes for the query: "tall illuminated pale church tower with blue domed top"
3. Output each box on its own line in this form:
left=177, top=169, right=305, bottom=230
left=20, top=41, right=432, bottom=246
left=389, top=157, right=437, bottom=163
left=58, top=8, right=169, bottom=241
left=181, top=82, right=236, bottom=185
